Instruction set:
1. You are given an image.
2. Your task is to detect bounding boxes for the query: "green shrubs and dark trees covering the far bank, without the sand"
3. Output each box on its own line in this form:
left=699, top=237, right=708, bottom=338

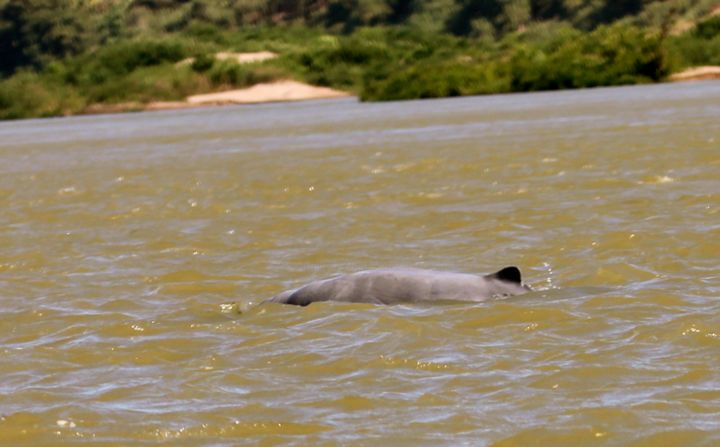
left=0, top=0, right=720, bottom=119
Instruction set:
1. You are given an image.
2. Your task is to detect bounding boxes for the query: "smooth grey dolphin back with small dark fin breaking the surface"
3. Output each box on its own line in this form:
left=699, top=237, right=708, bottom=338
left=265, top=267, right=530, bottom=306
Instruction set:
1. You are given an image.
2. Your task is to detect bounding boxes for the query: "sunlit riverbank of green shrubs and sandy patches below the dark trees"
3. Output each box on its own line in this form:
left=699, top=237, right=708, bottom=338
left=0, top=9, right=720, bottom=119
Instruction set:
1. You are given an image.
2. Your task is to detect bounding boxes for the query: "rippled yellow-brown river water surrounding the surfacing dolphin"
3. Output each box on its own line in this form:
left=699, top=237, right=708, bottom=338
left=0, top=82, right=720, bottom=446
